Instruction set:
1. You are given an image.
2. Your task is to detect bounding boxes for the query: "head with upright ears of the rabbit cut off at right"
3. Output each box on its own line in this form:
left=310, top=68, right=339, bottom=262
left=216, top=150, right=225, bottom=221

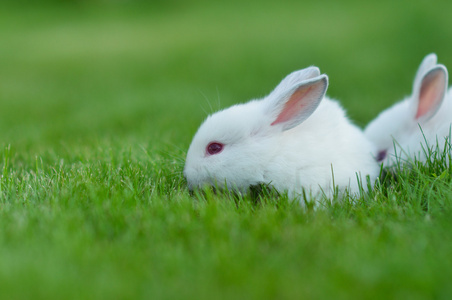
left=364, top=54, right=448, bottom=164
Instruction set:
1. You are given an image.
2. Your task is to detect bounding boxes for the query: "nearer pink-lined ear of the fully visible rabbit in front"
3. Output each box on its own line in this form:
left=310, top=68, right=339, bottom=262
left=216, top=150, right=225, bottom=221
left=268, top=74, right=328, bottom=131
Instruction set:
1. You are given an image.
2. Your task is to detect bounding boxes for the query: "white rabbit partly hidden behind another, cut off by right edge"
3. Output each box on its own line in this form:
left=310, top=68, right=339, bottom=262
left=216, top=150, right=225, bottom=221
left=364, top=54, right=452, bottom=166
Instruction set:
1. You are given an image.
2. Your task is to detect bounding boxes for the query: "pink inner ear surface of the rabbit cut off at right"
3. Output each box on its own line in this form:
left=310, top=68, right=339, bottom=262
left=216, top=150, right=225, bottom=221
left=416, top=72, right=444, bottom=119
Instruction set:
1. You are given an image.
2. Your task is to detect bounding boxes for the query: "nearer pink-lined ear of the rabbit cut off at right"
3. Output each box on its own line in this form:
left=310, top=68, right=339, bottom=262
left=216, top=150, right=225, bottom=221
left=411, top=65, right=448, bottom=121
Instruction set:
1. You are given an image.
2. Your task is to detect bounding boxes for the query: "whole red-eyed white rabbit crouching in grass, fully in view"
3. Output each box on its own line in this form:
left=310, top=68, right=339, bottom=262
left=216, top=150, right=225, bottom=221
left=184, top=67, right=380, bottom=200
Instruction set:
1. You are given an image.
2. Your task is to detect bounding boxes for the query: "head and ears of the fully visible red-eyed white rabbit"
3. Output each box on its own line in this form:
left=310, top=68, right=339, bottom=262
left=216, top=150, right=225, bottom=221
left=184, top=67, right=328, bottom=191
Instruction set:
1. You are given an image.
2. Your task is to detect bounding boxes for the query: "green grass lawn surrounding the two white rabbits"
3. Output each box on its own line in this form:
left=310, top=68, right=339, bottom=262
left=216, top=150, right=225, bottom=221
left=0, top=1, right=452, bottom=299
